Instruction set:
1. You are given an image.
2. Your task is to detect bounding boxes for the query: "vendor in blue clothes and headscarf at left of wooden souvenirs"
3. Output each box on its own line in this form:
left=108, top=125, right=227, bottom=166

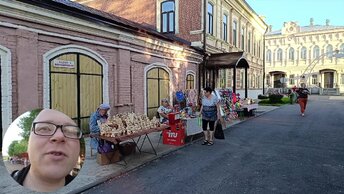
left=89, top=103, right=110, bottom=149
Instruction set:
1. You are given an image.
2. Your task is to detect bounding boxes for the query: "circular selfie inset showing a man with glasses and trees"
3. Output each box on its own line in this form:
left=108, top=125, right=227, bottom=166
left=2, top=109, right=85, bottom=192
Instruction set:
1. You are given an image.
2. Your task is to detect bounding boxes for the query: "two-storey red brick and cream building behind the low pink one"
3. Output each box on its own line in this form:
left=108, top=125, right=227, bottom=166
left=75, top=0, right=267, bottom=98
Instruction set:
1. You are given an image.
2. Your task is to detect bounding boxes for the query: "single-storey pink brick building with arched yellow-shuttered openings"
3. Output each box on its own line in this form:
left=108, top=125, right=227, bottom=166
left=0, top=0, right=202, bottom=136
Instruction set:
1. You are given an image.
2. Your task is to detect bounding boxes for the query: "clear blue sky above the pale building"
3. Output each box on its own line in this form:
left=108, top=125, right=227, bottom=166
left=246, top=0, right=344, bottom=31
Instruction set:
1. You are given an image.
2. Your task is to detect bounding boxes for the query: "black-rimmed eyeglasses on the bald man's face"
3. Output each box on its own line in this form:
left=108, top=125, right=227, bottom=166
left=32, top=122, right=82, bottom=139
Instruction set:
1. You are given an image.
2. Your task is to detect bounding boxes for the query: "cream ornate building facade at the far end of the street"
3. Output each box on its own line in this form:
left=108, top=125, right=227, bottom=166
left=265, top=19, right=344, bottom=95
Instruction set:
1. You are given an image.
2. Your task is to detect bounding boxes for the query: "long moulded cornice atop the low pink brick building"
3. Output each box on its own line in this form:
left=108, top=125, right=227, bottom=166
left=0, top=0, right=202, bottom=59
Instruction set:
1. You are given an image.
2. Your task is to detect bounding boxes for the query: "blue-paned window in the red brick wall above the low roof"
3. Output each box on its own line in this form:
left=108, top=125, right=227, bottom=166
left=161, top=1, right=175, bottom=33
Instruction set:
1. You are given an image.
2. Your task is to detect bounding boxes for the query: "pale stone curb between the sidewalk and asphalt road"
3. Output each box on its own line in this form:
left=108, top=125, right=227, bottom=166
left=68, top=107, right=280, bottom=194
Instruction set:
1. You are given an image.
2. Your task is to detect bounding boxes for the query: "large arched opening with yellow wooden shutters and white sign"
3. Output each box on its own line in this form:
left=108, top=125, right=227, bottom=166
left=49, top=53, right=104, bottom=130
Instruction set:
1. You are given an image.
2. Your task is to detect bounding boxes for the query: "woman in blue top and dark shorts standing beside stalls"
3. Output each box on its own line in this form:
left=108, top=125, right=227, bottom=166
left=200, top=87, right=220, bottom=146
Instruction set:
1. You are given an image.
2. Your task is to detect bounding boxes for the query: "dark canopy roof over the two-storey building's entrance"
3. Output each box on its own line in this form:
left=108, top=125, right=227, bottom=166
left=206, top=52, right=249, bottom=69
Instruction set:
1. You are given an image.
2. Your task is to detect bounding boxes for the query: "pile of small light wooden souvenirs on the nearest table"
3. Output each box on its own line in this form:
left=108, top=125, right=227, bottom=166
left=99, top=113, right=160, bottom=137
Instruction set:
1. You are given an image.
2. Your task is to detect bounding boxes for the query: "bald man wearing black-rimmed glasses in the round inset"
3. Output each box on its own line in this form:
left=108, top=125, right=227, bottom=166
left=11, top=109, right=82, bottom=192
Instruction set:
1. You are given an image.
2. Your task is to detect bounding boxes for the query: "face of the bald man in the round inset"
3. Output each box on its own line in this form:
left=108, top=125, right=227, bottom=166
left=28, top=109, right=80, bottom=181
